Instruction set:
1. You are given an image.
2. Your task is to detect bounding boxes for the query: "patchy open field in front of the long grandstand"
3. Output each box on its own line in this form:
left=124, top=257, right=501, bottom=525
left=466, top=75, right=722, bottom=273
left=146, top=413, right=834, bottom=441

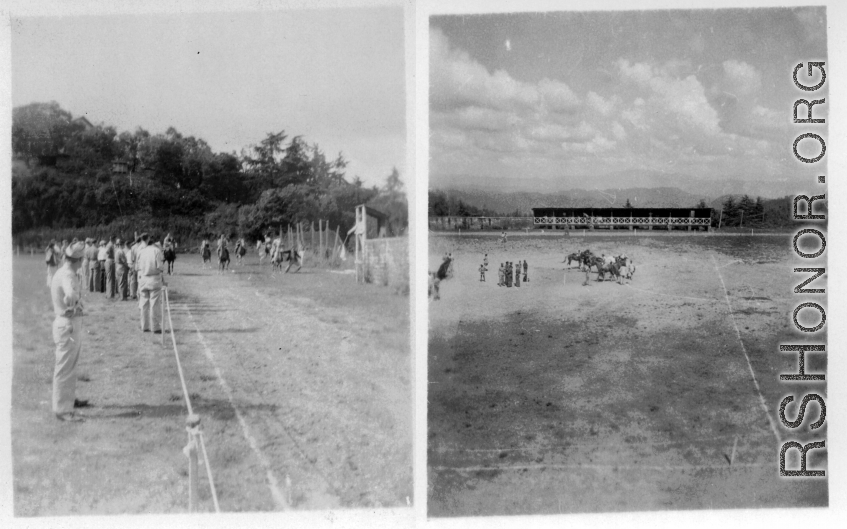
left=428, top=232, right=828, bottom=516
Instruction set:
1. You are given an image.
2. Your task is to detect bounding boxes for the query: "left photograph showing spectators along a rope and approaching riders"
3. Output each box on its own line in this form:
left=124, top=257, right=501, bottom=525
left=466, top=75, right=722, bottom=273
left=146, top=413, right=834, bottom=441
left=8, top=7, right=414, bottom=517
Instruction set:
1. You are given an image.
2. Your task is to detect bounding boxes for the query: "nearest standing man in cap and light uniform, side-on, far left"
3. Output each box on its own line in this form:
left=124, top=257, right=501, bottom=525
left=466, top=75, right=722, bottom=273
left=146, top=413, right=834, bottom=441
left=50, top=242, right=88, bottom=422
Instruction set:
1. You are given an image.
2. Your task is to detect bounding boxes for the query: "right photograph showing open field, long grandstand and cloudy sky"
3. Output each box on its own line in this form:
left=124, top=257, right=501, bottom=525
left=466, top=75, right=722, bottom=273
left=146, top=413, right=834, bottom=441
left=427, top=7, right=829, bottom=517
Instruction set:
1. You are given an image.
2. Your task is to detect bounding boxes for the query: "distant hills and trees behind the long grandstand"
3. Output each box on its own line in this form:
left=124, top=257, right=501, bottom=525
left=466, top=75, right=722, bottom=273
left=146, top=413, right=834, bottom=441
left=429, top=188, right=816, bottom=229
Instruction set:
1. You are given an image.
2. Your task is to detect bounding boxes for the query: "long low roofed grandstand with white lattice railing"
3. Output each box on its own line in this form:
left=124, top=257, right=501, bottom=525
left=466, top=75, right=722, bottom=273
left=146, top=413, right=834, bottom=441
left=532, top=207, right=712, bottom=231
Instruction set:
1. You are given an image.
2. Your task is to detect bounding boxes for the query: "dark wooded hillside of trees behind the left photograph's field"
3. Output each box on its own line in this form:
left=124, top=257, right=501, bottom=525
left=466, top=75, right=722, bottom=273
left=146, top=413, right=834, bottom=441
left=12, top=102, right=408, bottom=246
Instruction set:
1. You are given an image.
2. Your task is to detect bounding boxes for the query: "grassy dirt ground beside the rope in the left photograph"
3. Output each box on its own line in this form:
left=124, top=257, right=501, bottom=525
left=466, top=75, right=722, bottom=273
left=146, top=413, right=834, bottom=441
left=11, top=253, right=412, bottom=516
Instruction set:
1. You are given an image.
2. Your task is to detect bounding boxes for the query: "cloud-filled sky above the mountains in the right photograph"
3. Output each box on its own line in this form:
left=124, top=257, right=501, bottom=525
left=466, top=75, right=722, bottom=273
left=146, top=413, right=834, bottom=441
left=429, top=8, right=826, bottom=196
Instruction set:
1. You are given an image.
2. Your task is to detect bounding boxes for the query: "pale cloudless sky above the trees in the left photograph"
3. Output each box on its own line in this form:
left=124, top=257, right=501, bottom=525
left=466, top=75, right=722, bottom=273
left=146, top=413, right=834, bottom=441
left=12, top=7, right=405, bottom=185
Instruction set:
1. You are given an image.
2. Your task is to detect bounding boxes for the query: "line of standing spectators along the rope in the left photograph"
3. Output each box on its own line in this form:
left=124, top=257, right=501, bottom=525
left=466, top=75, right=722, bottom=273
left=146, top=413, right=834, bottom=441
left=45, top=233, right=173, bottom=422
